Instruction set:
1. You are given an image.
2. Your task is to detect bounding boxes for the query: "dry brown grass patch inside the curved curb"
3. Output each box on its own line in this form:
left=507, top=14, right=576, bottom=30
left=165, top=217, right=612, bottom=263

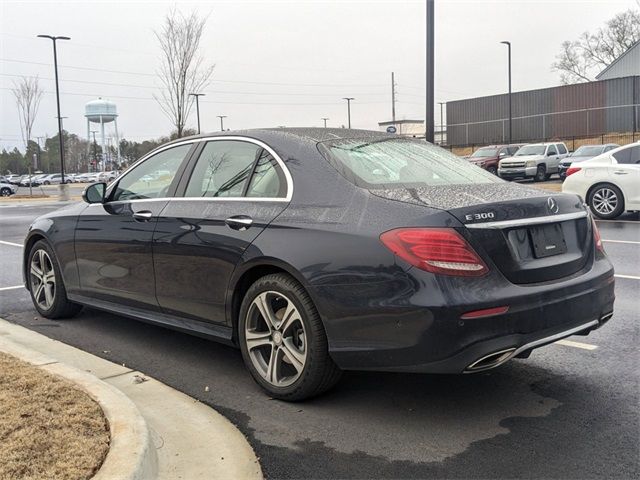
left=0, top=352, right=109, bottom=480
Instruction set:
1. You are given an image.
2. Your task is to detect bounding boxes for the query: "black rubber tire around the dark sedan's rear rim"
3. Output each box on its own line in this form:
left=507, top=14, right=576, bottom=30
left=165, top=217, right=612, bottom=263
left=238, top=274, right=342, bottom=402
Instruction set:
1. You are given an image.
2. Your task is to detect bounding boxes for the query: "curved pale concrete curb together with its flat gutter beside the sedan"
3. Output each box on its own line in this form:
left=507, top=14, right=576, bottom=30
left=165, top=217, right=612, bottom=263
left=0, top=317, right=263, bottom=480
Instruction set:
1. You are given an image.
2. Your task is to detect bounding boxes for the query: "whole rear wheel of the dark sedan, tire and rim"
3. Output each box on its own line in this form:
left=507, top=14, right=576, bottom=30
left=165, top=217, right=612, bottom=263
left=238, top=274, right=341, bottom=401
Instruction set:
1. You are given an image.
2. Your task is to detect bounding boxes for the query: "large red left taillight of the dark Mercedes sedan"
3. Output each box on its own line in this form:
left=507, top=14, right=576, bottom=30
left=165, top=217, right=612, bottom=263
left=380, top=228, right=489, bottom=277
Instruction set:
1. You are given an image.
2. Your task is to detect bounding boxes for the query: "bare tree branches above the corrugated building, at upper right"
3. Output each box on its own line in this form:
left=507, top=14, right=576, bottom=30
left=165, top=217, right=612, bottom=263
left=551, top=7, right=640, bottom=85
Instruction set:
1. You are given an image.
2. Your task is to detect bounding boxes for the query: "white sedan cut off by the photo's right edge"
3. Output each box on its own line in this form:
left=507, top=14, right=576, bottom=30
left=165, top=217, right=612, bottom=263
left=562, top=142, right=640, bottom=219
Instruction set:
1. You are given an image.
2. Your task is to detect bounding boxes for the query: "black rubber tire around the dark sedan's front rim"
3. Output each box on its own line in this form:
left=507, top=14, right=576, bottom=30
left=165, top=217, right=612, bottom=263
left=27, top=240, right=82, bottom=319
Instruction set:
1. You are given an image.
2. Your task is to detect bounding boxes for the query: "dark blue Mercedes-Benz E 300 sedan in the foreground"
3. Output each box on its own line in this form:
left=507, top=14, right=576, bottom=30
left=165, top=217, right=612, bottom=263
left=24, top=129, right=614, bottom=400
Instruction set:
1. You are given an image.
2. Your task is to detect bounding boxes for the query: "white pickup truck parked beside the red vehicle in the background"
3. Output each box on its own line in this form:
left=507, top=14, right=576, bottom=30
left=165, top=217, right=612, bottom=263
left=498, top=142, right=569, bottom=182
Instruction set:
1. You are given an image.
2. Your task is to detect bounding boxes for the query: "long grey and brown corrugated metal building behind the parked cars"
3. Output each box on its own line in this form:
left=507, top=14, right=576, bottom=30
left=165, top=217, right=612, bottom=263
left=447, top=76, right=640, bottom=146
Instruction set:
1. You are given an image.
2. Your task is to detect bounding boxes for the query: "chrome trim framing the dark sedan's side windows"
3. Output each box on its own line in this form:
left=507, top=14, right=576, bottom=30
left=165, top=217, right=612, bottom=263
left=105, top=135, right=293, bottom=205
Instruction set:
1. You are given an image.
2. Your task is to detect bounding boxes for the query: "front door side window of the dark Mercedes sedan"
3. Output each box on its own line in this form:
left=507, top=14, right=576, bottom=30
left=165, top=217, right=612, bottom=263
left=111, top=144, right=191, bottom=201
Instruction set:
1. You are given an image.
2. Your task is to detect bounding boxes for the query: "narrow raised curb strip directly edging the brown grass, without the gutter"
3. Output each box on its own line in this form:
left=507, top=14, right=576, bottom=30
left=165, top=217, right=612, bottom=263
left=0, top=325, right=158, bottom=480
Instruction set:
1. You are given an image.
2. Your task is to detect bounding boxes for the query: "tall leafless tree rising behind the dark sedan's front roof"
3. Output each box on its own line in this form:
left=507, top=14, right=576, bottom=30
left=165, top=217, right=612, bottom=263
left=154, top=10, right=214, bottom=137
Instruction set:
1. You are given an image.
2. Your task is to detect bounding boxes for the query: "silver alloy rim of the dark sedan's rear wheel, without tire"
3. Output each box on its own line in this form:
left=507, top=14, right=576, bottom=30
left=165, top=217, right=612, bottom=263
left=245, top=291, right=307, bottom=387
